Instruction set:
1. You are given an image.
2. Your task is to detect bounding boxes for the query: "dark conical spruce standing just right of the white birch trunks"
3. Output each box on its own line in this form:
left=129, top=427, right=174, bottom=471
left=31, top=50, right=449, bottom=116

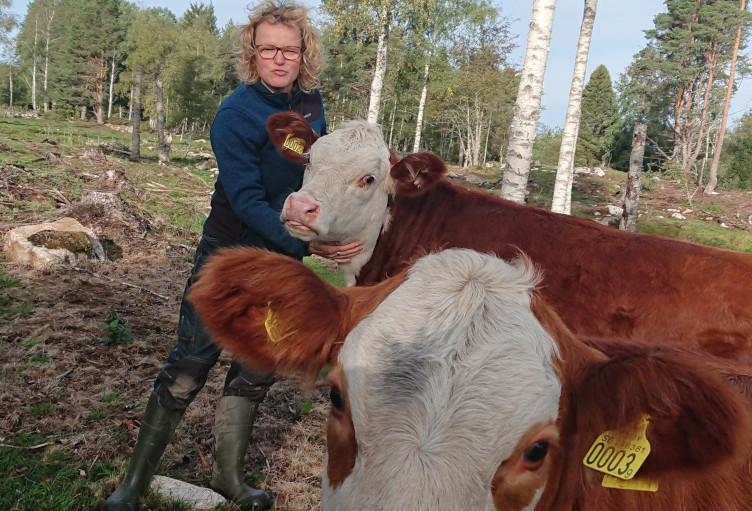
left=575, top=65, right=619, bottom=167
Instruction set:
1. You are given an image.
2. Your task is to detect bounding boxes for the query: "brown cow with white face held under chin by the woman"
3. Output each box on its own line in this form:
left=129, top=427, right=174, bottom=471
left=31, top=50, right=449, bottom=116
left=267, top=113, right=752, bottom=362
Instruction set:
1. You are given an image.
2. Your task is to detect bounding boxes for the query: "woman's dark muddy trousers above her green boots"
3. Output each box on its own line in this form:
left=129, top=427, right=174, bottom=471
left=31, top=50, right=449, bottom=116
left=154, top=234, right=275, bottom=410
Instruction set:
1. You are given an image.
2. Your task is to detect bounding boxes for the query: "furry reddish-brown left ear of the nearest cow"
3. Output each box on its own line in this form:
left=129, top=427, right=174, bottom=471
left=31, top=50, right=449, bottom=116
left=188, top=247, right=399, bottom=384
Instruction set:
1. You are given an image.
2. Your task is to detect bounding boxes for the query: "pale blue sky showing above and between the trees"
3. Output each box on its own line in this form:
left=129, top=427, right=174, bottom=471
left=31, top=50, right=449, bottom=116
left=11, top=0, right=752, bottom=127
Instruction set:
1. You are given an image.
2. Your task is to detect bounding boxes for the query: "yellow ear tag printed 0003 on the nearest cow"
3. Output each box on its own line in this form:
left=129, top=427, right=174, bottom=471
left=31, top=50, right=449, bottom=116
left=582, top=415, right=650, bottom=482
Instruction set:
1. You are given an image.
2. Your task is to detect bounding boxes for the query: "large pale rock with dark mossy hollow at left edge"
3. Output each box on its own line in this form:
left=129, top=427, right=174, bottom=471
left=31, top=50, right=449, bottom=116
left=3, top=218, right=104, bottom=270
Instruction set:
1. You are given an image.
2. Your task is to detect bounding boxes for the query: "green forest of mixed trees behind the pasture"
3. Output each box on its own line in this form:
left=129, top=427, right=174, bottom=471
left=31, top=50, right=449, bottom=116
left=0, top=0, right=752, bottom=189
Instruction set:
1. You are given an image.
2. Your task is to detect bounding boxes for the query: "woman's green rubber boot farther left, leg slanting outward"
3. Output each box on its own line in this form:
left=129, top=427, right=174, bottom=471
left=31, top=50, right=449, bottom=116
left=103, top=394, right=183, bottom=511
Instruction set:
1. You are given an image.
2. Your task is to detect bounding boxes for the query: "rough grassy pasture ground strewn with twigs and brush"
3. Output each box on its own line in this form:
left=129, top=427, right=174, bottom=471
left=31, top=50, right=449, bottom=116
left=0, top=119, right=752, bottom=511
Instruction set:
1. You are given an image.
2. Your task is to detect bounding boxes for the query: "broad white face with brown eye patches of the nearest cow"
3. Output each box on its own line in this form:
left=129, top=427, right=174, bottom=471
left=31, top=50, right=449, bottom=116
left=322, top=249, right=561, bottom=511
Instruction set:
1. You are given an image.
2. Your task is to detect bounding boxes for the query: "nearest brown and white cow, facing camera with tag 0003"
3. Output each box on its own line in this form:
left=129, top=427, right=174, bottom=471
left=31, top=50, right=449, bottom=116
left=190, top=248, right=752, bottom=511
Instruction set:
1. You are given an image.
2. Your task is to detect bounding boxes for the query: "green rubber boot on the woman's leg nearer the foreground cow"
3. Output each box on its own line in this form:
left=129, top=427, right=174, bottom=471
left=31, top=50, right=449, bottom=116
left=209, top=396, right=272, bottom=511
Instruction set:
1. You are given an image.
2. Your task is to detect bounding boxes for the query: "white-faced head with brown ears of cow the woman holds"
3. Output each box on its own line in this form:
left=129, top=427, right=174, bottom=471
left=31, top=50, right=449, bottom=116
left=266, top=112, right=446, bottom=286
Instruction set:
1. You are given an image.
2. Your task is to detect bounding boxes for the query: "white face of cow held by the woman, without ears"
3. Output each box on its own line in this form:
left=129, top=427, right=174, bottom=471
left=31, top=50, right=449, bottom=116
left=281, top=121, right=393, bottom=286
